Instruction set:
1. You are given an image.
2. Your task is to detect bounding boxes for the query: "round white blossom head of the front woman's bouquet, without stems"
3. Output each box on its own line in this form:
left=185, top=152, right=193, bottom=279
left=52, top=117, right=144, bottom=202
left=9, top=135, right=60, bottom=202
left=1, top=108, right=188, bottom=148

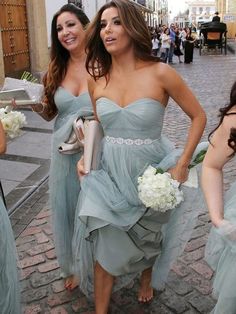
left=138, top=166, right=184, bottom=212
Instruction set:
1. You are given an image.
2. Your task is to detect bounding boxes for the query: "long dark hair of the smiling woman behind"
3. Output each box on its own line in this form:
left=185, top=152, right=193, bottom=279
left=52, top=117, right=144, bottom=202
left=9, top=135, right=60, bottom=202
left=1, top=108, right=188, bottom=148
left=43, top=3, right=89, bottom=112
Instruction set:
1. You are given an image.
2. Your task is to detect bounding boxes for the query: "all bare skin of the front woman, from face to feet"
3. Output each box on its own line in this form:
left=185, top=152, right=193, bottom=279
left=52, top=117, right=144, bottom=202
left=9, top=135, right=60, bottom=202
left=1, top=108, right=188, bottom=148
left=78, top=8, right=206, bottom=314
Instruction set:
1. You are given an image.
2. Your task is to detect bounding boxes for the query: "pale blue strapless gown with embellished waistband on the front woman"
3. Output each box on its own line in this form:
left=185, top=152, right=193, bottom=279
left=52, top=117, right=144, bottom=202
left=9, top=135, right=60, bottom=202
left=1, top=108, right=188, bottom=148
left=73, top=97, right=206, bottom=297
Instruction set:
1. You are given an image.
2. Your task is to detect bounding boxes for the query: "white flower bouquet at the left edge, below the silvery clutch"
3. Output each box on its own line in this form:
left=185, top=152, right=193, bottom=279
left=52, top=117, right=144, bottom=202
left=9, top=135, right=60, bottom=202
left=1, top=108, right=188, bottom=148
left=0, top=106, right=26, bottom=138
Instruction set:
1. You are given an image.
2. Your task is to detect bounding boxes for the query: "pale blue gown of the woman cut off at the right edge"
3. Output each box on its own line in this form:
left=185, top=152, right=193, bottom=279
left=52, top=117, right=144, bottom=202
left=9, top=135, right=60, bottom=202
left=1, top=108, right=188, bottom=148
left=205, top=159, right=236, bottom=314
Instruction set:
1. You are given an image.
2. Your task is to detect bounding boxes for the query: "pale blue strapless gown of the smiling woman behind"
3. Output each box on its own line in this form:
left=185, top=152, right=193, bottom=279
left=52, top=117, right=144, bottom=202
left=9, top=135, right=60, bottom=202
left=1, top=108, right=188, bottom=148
left=49, top=87, right=92, bottom=277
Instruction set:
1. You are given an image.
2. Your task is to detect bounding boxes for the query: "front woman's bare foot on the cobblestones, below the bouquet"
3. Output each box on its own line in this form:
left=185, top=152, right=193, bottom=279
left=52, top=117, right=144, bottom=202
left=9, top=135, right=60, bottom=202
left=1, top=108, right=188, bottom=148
left=138, top=268, right=153, bottom=303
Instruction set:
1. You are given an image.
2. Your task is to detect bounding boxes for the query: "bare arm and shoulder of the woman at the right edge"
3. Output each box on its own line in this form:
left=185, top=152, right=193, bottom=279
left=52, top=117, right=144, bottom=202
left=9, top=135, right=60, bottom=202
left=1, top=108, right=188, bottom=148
left=202, top=106, right=236, bottom=227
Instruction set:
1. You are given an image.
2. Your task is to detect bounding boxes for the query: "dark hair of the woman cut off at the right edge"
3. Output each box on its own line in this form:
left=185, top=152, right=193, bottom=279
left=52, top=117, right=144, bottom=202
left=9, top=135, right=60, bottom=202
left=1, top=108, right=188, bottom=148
left=208, top=81, right=236, bottom=157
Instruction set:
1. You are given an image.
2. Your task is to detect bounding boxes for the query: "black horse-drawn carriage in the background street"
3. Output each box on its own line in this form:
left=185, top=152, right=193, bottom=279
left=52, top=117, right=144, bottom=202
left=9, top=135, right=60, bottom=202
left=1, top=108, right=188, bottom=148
left=199, top=22, right=227, bottom=55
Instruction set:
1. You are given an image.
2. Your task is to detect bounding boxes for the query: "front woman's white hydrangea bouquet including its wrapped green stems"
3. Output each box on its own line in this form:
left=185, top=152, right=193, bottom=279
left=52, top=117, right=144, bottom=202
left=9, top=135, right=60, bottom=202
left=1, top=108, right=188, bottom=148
left=138, top=148, right=207, bottom=212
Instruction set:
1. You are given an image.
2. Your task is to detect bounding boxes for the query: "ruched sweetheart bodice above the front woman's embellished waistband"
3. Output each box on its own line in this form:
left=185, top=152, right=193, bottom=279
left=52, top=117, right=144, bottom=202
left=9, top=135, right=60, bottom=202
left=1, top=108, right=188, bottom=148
left=96, top=97, right=165, bottom=139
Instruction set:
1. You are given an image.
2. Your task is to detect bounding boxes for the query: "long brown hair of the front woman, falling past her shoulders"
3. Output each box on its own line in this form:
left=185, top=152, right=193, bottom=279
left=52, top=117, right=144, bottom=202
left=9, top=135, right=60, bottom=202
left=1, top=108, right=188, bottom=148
left=86, top=0, right=159, bottom=80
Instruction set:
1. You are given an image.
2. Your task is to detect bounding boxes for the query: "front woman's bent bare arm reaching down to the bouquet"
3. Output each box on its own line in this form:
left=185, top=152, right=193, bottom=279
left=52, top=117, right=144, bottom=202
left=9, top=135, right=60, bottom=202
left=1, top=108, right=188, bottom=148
left=161, top=66, right=206, bottom=182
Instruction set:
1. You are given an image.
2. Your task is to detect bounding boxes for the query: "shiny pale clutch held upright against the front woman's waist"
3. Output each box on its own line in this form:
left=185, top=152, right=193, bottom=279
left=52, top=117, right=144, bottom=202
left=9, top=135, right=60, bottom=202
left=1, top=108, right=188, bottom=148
left=84, top=120, right=103, bottom=173
